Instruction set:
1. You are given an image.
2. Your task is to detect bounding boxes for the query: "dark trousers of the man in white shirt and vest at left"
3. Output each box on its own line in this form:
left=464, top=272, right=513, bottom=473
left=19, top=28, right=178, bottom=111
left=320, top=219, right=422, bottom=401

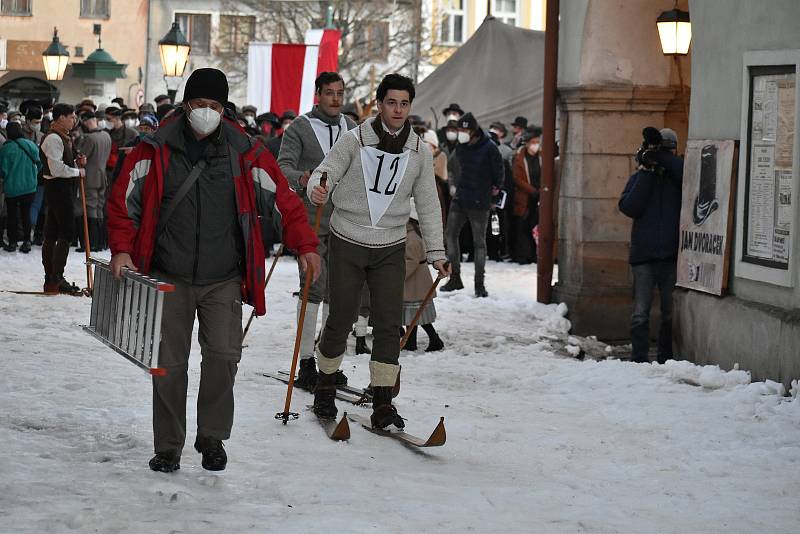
left=42, top=178, right=75, bottom=283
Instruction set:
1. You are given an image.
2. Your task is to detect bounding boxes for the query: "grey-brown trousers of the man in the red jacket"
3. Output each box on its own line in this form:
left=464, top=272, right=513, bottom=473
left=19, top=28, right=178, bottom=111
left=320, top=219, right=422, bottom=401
left=153, top=273, right=242, bottom=454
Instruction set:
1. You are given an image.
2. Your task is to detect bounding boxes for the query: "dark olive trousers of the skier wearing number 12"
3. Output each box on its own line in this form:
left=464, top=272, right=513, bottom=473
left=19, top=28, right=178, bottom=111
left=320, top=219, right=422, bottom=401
left=319, top=235, right=406, bottom=365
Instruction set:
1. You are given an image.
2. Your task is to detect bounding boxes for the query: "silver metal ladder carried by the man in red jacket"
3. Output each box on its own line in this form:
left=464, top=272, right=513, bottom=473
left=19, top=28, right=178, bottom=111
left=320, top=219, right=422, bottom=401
left=83, top=258, right=175, bottom=376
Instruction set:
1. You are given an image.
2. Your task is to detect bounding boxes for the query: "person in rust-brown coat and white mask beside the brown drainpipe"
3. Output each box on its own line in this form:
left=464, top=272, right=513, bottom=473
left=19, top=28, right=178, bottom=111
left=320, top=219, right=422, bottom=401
left=513, top=126, right=542, bottom=264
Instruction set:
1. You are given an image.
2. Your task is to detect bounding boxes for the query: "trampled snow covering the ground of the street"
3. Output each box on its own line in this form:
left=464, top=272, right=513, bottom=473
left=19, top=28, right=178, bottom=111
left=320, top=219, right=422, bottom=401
left=0, top=252, right=800, bottom=534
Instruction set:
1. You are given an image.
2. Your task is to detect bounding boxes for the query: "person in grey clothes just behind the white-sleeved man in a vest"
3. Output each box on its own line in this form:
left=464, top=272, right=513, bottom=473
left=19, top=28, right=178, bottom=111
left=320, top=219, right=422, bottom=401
left=75, top=109, right=111, bottom=252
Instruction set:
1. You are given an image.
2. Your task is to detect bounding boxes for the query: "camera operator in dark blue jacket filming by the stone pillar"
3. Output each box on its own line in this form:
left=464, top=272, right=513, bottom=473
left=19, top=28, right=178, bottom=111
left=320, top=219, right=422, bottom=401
left=619, top=127, right=683, bottom=363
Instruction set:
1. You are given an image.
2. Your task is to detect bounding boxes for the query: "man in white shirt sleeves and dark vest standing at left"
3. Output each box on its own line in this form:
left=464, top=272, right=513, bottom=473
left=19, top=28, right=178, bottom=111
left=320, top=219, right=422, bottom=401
left=40, top=104, right=86, bottom=294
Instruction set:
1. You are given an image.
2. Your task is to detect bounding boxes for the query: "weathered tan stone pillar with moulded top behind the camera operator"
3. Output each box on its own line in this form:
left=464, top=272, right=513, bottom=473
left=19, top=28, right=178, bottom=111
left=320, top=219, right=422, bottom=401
left=553, top=84, right=677, bottom=341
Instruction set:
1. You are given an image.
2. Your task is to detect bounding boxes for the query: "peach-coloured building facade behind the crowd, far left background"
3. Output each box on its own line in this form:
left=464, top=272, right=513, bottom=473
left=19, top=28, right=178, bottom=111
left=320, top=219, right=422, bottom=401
left=0, top=0, right=149, bottom=107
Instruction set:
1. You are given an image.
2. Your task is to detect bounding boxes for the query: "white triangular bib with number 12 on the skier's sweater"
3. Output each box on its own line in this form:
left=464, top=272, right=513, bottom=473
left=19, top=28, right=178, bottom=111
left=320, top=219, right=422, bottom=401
left=361, top=146, right=410, bottom=228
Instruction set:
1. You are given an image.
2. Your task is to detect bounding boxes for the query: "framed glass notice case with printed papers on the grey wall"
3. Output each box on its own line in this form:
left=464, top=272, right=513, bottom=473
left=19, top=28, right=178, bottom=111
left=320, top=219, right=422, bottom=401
left=742, top=66, right=797, bottom=270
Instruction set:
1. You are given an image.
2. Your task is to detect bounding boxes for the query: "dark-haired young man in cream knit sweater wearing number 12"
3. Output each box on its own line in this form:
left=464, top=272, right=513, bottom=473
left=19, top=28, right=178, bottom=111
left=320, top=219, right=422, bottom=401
left=307, top=74, right=449, bottom=429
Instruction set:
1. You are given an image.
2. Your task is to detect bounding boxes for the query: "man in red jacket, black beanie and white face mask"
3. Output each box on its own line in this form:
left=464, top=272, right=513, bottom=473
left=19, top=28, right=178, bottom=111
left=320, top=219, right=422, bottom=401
left=108, top=69, right=320, bottom=472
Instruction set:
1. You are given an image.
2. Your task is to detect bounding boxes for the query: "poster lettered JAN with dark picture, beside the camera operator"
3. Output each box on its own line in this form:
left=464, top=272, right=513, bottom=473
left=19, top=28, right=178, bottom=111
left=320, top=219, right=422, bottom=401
left=678, top=140, right=737, bottom=295
